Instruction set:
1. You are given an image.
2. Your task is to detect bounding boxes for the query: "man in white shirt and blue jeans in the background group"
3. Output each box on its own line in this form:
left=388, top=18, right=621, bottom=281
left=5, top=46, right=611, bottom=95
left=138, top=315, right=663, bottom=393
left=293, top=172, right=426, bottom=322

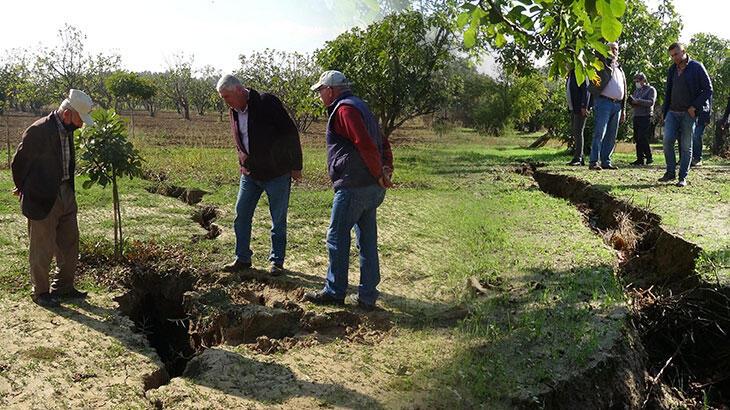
left=589, top=43, right=626, bottom=170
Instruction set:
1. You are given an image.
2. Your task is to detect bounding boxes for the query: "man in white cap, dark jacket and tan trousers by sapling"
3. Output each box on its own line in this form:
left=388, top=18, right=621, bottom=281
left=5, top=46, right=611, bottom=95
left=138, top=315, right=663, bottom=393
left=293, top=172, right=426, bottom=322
left=12, top=89, right=94, bottom=307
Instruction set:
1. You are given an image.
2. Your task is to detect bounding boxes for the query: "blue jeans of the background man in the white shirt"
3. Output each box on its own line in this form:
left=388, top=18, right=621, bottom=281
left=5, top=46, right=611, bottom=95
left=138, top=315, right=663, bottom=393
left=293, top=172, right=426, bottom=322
left=590, top=97, right=621, bottom=166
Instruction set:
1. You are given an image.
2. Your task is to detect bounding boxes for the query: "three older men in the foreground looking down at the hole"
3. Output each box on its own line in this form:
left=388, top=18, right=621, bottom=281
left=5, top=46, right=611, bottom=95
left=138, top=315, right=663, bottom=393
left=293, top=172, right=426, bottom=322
left=12, top=71, right=393, bottom=310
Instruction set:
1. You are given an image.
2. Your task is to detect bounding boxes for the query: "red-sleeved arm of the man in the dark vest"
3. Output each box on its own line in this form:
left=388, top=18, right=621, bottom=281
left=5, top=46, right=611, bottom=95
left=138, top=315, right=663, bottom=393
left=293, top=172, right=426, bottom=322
left=334, top=104, right=384, bottom=180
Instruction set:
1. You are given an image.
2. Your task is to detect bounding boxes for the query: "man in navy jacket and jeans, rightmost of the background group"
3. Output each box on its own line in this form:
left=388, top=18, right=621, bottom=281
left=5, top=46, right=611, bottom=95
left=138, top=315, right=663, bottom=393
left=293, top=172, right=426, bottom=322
left=659, top=43, right=712, bottom=187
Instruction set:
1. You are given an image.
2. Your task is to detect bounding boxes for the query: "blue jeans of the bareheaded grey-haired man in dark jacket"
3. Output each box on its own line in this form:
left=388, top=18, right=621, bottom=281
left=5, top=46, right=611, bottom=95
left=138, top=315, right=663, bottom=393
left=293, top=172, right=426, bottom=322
left=233, top=174, right=291, bottom=265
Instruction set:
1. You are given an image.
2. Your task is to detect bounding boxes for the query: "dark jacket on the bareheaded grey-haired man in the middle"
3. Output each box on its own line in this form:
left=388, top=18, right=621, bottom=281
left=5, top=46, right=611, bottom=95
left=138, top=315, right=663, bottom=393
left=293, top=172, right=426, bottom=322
left=230, top=89, right=302, bottom=181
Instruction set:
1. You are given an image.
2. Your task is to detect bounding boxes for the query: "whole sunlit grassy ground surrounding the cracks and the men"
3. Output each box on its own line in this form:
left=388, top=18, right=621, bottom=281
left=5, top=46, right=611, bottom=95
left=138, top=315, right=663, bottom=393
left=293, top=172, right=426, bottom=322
left=0, top=110, right=730, bottom=408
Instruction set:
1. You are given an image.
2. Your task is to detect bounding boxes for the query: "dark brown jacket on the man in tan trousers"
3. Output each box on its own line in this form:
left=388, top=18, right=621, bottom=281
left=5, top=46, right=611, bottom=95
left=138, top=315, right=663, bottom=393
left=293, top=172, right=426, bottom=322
left=12, top=113, right=76, bottom=220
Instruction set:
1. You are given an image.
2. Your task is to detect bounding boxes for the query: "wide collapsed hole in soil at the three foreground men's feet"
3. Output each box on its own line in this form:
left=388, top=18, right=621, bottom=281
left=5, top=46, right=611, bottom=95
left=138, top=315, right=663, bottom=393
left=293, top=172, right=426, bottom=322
left=80, top=243, right=392, bottom=396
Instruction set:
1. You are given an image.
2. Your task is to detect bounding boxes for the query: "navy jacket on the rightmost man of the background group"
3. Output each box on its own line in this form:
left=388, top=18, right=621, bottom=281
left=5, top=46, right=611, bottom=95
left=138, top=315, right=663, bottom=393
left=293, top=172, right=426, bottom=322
left=663, top=57, right=712, bottom=124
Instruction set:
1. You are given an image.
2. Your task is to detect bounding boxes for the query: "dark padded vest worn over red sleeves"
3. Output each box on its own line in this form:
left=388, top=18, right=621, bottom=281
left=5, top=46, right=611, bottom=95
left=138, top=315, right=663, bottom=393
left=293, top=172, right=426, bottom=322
left=327, top=92, right=383, bottom=189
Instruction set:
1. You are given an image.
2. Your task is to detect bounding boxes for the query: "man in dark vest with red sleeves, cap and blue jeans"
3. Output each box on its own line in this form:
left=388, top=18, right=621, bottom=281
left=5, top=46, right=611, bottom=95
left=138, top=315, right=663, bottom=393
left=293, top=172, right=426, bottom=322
left=304, top=70, right=393, bottom=310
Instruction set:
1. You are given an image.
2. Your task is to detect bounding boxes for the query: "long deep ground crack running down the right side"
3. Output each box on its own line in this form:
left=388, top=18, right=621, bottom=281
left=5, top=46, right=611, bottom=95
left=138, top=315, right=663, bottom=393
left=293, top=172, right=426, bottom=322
left=517, top=164, right=730, bottom=408
